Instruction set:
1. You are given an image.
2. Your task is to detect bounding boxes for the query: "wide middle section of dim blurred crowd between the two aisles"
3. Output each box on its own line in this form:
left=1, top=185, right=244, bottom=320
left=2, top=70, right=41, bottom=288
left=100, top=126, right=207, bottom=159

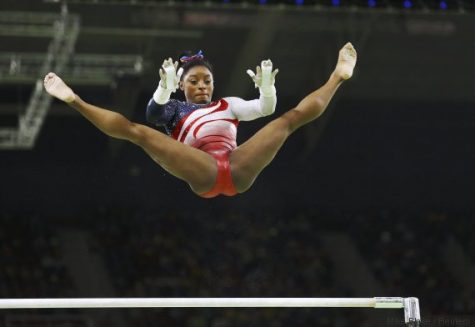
left=89, top=211, right=350, bottom=326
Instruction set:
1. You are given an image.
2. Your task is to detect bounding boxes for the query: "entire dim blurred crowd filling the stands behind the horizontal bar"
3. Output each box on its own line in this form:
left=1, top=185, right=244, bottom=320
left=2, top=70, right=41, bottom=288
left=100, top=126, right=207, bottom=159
left=0, top=208, right=475, bottom=327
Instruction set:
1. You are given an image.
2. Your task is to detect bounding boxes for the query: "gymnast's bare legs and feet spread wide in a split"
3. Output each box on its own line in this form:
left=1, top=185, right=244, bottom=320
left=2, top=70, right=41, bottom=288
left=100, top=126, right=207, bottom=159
left=44, top=43, right=356, bottom=195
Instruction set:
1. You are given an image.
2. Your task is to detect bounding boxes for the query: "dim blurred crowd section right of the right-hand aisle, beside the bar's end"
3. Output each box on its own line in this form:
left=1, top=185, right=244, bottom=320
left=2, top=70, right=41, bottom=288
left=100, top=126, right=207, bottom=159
left=351, top=211, right=475, bottom=315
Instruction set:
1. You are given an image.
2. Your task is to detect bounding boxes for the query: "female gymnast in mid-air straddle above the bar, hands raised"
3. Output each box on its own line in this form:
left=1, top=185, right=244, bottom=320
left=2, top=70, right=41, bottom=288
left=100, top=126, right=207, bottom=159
left=44, top=43, right=357, bottom=198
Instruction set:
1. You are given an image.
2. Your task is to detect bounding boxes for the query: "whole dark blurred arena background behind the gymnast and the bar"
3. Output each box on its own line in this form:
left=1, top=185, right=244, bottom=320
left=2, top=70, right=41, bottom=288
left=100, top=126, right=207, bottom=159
left=0, top=0, right=475, bottom=327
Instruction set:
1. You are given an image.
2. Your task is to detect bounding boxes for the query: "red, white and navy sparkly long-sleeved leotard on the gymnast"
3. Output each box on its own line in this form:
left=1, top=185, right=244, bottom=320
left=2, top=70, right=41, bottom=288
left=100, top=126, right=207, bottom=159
left=147, top=96, right=276, bottom=198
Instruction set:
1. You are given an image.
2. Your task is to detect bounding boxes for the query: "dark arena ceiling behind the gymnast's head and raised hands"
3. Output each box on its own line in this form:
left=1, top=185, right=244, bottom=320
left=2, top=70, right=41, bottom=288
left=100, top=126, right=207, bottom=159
left=0, top=0, right=475, bottom=107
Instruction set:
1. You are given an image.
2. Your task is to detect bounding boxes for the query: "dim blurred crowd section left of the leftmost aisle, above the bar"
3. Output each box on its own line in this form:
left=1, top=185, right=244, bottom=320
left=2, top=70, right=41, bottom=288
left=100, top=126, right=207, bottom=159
left=0, top=214, right=75, bottom=298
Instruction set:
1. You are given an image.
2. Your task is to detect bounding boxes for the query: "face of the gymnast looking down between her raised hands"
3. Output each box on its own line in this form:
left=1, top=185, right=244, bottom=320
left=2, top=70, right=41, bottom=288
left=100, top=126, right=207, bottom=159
left=180, top=66, right=214, bottom=104
